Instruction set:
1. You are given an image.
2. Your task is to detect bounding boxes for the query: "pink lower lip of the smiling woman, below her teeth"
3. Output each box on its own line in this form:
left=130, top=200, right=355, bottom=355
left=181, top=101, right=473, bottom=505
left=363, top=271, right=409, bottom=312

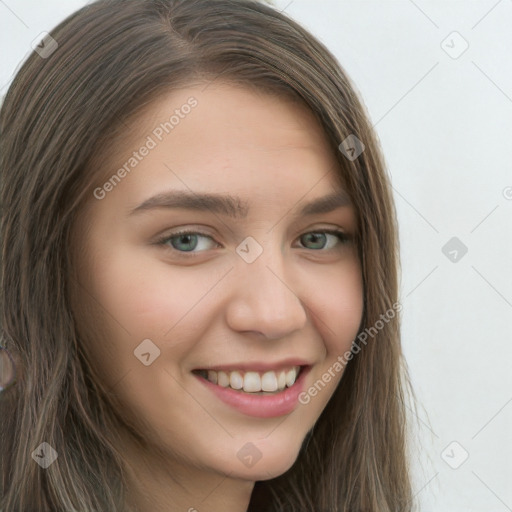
left=196, top=366, right=310, bottom=418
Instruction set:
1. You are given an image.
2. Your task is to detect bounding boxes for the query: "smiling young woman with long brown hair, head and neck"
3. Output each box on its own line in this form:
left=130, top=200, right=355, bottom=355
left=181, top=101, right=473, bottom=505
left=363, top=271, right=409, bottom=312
left=0, top=0, right=412, bottom=512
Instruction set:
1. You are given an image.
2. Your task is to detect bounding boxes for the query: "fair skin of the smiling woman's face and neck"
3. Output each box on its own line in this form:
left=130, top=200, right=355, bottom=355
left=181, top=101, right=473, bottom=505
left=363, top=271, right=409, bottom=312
left=71, top=83, right=363, bottom=512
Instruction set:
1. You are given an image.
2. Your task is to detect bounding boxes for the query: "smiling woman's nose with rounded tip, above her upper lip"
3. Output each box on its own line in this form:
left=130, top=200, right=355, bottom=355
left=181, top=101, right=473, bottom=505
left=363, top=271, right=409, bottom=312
left=226, top=244, right=307, bottom=339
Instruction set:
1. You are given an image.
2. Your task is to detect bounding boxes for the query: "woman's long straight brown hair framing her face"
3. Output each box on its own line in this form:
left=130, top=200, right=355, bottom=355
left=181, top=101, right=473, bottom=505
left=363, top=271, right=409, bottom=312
left=0, top=0, right=412, bottom=512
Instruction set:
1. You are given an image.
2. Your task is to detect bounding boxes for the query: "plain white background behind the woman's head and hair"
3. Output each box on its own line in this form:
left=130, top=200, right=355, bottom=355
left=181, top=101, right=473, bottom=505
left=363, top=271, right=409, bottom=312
left=0, top=0, right=512, bottom=512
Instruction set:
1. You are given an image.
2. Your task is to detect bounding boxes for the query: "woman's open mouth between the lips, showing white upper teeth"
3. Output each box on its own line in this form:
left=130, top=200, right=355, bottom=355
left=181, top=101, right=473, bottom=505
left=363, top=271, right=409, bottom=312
left=192, top=366, right=307, bottom=395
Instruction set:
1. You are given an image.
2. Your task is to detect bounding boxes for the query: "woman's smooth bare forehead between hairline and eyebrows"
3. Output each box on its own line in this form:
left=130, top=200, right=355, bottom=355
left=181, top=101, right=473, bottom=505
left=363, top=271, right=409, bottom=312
left=88, top=83, right=350, bottom=216
